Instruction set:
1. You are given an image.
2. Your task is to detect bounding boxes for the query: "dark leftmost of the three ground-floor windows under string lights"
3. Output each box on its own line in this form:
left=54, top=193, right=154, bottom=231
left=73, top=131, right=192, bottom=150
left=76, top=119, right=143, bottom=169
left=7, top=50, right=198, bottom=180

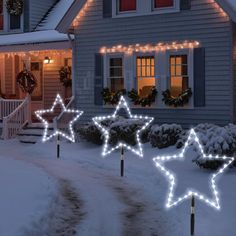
left=109, top=57, right=124, bottom=93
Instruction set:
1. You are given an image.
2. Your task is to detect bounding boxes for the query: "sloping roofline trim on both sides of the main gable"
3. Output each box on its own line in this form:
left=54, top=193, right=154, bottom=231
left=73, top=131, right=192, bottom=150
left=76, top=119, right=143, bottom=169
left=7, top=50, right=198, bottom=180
left=56, top=0, right=236, bottom=33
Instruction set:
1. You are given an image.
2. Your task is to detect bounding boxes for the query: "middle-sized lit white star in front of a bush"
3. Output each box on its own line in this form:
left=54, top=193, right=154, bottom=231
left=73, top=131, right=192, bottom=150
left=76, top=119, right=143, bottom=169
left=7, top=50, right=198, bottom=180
left=93, top=96, right=154, bottom=157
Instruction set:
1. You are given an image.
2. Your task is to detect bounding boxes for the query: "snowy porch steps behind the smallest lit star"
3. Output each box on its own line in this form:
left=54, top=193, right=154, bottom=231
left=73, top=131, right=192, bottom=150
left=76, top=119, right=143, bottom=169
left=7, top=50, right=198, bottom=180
left=17, top=123, right=53, bottom=144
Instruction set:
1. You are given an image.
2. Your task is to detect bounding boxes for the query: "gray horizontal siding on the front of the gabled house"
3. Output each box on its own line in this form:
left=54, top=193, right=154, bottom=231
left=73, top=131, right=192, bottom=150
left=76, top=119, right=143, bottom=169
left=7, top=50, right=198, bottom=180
left=75, top=0, right=233, bottom=126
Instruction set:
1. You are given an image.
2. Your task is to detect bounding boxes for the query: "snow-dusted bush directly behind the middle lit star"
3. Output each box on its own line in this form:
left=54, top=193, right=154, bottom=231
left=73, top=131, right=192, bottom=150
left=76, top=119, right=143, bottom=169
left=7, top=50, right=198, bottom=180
left=77, top=117, right=149, bottom=146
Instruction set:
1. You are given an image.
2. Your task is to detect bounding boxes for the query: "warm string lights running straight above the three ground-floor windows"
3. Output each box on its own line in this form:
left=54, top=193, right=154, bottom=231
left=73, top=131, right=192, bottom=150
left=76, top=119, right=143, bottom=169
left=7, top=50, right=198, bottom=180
left=100, top=41, right=200, bottom=54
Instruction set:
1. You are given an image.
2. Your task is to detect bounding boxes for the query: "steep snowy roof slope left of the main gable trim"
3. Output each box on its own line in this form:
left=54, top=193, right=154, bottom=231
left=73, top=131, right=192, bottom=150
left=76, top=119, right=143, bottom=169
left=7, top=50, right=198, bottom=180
left=36, top=0, right=74, bottom=31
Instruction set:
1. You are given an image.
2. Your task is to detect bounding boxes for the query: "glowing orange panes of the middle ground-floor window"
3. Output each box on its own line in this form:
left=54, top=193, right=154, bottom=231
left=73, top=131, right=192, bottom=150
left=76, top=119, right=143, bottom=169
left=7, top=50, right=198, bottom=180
left=137, top=56, right=156, bottom=97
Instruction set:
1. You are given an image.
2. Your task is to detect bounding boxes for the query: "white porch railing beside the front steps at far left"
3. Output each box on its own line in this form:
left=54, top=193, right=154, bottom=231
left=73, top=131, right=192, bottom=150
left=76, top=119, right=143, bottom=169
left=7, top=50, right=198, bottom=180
left=0, top=96, right=31, bottom=139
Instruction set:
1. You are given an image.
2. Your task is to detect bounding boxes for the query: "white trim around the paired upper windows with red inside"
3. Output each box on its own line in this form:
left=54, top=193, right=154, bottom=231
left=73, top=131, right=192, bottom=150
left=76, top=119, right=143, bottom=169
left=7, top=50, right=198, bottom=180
left=112, top=0, right=180, bottom=18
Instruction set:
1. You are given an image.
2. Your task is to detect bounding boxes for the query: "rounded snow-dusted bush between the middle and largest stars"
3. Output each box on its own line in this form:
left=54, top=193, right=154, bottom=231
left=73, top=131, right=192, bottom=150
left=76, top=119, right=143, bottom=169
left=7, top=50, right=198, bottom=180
left=149, top=124, right=183, bottom=148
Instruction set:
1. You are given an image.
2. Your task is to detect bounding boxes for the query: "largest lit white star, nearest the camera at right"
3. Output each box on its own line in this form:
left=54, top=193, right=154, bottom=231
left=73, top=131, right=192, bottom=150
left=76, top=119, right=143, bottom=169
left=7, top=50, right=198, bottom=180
left=153, top=129, right=234, bottom=210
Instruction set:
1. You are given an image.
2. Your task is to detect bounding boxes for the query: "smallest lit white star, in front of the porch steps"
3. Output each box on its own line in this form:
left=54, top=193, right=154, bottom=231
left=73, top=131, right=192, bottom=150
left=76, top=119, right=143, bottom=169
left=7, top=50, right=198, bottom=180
left=35, top=94, right=83, bottom=143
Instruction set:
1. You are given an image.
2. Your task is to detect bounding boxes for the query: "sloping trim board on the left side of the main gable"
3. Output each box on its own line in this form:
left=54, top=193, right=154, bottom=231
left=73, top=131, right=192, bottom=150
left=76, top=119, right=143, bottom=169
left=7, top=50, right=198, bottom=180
left=56, top=0, right=87, bottom=33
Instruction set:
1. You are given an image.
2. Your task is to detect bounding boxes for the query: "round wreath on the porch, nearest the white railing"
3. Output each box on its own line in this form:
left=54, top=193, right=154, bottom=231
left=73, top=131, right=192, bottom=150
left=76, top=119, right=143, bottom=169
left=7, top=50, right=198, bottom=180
left=16, top=69, right=37, bottom=94
